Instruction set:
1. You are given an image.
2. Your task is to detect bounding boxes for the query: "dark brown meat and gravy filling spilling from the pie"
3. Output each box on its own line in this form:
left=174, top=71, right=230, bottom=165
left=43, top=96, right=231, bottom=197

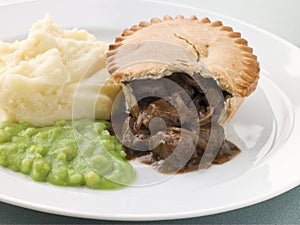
left=121, top=73, right=240, bottom=173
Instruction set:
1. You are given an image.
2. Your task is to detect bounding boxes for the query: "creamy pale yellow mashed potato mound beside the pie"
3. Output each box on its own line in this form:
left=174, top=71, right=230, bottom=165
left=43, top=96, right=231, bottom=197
left=0, top=17, right=120, bottom=126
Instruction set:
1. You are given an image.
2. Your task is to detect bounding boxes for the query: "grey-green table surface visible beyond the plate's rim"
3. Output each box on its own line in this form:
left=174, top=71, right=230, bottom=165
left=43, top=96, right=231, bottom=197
left=0, top=0, right=300, bottom=224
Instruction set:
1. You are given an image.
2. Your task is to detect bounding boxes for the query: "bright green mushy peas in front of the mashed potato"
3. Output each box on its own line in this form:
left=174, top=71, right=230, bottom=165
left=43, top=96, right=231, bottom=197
left=0, top=119, right=135, bottom=189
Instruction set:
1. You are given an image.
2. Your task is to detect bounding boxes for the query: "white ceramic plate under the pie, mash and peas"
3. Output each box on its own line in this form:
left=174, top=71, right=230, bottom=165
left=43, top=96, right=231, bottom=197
left=0, top=0, right=300, bottom=220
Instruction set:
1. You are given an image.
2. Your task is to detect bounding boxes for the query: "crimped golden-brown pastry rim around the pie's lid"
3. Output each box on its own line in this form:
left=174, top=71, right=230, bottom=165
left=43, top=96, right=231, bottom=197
left=107, top=15, right=260, bottom=97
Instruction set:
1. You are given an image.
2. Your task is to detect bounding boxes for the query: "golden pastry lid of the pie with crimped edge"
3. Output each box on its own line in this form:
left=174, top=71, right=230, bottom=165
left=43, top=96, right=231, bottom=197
left=107, top=16, right=260, bottom=97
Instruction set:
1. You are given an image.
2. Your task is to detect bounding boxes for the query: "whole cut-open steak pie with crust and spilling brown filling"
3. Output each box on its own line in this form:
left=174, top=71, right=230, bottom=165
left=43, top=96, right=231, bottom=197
left=107, top=16, right=260, bottom=173
